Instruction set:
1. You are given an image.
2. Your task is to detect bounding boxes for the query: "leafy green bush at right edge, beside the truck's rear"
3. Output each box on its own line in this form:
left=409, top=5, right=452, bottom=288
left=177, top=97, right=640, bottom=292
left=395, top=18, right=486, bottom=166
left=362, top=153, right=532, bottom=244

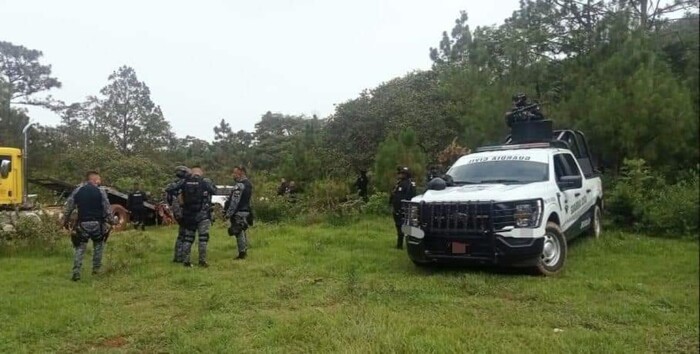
left=606, top=160, right=700, bottom=236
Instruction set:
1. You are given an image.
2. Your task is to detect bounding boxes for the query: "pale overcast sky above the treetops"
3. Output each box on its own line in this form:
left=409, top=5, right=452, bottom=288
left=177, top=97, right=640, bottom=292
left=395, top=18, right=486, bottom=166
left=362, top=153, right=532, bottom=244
left=0, top=0, right=518, bottom=140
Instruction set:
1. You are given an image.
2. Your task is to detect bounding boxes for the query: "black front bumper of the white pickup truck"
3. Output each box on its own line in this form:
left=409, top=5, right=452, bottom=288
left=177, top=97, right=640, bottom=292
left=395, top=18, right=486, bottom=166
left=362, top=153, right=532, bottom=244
left=406, top=233, right=544, bottom=266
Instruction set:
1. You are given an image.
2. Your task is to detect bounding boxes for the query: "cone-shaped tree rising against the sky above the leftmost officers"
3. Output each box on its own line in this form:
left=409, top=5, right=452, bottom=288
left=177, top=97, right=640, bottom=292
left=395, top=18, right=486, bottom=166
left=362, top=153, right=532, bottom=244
left=94, top=66, right=172, bottom=154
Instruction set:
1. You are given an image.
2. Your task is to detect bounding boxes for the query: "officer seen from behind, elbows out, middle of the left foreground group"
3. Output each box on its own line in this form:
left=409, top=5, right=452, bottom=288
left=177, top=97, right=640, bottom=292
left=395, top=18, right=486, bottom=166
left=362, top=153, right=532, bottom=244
left=166, top=166, right=216, bottom=268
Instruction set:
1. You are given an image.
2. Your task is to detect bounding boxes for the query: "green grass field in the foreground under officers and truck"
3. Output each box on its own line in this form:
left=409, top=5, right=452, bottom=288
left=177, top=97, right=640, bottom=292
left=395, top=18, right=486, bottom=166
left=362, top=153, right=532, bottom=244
left=0, top=219, right=699, bottom=353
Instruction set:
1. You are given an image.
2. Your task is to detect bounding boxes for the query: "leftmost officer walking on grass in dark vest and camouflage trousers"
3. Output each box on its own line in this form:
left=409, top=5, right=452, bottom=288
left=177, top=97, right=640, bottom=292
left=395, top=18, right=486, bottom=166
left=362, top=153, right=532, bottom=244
left=63, top=171, right=114, bottom=281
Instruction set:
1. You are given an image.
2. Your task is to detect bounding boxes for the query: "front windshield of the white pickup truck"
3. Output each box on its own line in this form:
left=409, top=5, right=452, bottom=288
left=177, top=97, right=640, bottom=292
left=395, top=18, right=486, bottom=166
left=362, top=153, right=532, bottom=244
left=447, top=161, right=549, bottom=184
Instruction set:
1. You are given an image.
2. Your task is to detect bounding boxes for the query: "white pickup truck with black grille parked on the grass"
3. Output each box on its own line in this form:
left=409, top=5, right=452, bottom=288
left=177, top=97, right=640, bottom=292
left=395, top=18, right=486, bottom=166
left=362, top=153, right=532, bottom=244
left=402, top=131, right=603, bottom=275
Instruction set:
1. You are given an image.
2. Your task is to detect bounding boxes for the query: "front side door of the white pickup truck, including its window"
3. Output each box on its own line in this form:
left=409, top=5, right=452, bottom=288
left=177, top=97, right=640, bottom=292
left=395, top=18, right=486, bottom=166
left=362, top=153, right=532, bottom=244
left=554, top=153, right=588, bottom=237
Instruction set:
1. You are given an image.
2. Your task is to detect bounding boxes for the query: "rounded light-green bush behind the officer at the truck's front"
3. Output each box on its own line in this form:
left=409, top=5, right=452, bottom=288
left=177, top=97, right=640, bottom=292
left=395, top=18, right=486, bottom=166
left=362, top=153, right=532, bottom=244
left=374, top=128, right=425, bottom=192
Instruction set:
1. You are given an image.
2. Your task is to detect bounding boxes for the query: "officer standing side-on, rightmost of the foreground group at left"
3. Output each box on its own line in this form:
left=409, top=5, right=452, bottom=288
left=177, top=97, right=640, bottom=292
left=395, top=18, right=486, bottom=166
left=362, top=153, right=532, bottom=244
left=226, top=166, right=253, bottom=259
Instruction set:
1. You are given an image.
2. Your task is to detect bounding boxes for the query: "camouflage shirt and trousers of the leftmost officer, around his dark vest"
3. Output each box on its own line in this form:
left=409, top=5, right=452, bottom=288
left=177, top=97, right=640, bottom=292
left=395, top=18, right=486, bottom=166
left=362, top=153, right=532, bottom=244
left=63, top=183, right=114, bottom=280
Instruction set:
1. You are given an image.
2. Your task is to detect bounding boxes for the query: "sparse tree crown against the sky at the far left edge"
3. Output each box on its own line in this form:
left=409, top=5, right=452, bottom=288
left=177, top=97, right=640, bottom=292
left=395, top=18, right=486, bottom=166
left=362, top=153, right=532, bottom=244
left=0, top=41, right=61, bottom=107
